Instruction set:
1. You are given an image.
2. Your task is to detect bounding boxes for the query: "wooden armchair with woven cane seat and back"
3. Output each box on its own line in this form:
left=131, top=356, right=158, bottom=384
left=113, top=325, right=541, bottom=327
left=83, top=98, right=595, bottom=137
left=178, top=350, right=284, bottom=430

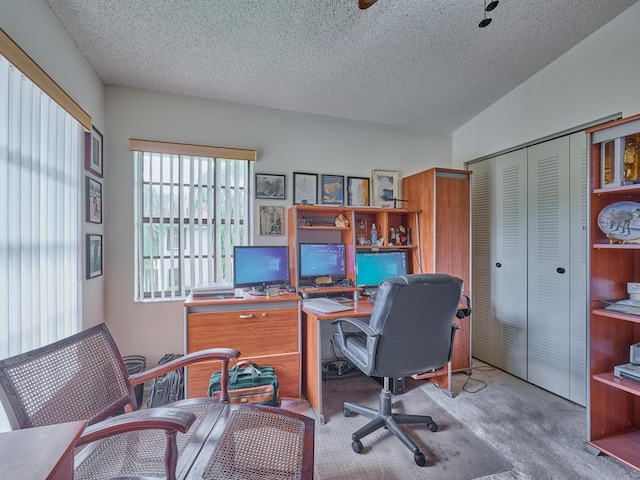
left=0, top=324, right=240, bottom=480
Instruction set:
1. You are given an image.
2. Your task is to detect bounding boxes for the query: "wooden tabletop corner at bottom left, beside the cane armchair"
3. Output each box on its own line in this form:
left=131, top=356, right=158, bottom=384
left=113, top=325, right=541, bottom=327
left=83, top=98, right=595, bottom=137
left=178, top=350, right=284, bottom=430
left=0, top=420, right=87, bottom=480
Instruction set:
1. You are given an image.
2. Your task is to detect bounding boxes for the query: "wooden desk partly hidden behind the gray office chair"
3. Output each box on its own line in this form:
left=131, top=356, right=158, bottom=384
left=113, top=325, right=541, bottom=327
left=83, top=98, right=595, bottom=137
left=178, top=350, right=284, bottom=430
left=301, top=299, right=469, bottom=424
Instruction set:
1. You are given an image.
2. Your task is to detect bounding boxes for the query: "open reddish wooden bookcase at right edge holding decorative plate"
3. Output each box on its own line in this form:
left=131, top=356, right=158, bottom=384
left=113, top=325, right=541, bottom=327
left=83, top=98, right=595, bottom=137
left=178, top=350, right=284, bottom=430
left=587, top=115, right=640, bottom=470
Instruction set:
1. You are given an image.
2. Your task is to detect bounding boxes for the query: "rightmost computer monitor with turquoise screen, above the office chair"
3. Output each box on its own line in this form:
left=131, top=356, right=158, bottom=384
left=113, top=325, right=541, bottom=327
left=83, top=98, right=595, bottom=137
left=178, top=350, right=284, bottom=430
left=356, top=250, right=407, bottom=287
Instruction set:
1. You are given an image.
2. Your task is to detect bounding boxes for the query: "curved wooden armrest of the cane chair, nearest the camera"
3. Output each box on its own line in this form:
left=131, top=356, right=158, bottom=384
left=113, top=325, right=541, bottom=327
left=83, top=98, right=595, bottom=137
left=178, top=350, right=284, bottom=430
left=77, top=408, right=196, bottom=445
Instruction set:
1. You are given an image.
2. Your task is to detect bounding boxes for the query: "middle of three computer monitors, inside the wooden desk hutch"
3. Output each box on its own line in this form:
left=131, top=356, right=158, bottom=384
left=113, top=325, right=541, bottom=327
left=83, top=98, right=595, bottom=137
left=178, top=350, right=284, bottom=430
left=298, top=243, right=347, bottom=284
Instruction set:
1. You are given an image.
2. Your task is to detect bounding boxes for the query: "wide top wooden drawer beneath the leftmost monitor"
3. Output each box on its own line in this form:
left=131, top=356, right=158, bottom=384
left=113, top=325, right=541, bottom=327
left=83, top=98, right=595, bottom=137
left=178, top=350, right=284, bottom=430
left=187, top=308, right=298, bottom=358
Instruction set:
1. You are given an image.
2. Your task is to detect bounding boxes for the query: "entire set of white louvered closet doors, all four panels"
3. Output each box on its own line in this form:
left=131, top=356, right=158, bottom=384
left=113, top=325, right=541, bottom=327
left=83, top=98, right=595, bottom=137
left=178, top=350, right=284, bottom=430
left=470, top=132, right=587, bottom=405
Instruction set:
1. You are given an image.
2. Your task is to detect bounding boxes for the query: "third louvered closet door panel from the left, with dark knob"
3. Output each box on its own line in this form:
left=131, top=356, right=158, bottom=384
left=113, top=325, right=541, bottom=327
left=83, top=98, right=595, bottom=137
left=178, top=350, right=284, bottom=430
left=528, top=137, right=571, bottom=397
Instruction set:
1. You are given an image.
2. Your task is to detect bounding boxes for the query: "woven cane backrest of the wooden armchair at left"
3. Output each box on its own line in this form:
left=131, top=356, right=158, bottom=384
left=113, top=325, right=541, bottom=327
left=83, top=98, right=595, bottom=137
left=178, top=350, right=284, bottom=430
left=0, top=323, right=133, bottom=430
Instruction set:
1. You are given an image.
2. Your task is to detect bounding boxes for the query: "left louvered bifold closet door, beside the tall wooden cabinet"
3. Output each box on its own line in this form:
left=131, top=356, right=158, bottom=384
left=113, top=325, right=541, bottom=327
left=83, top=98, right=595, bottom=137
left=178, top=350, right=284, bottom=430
left=471, top=150, right=527, bottom=380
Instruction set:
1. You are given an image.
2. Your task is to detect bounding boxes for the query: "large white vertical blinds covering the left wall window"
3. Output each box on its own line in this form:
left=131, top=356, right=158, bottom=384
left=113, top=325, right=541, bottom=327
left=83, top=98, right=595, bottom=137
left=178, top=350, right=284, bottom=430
left=0, top=56, right=82, bottom=358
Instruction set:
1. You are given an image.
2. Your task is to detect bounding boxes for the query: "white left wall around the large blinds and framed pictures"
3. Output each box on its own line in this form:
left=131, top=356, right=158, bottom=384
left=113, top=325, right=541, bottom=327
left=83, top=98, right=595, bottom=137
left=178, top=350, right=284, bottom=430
left=0, top=0, right=106, bottom=328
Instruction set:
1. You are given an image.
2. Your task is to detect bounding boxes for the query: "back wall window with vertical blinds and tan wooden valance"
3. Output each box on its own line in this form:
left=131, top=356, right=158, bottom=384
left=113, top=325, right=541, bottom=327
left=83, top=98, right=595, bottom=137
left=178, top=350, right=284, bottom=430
left=130, top=139, right=255, bottom=300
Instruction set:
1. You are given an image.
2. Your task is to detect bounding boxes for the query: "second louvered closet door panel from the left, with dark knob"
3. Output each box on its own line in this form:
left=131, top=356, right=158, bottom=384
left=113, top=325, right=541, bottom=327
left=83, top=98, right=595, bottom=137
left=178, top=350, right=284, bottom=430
left=492, top=149, right=527, bottom=380
